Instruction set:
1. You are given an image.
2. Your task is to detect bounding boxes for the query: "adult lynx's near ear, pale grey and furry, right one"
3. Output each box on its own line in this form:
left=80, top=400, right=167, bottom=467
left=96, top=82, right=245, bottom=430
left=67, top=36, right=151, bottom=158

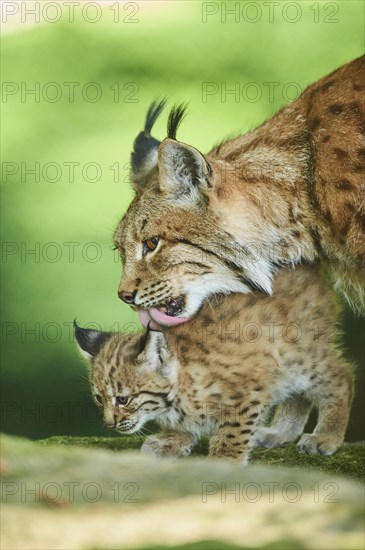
left=158, top=138, right=211, bottom=202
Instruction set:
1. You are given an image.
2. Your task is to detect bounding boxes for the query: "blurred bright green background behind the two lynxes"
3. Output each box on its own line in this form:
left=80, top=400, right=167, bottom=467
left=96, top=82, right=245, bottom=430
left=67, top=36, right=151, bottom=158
left=1, top=0, right=364, bottom=440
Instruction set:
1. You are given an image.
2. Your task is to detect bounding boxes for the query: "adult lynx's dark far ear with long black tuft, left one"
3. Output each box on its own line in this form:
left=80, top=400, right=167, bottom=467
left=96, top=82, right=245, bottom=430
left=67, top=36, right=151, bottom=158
left=130, top=99, right=166, bottom=192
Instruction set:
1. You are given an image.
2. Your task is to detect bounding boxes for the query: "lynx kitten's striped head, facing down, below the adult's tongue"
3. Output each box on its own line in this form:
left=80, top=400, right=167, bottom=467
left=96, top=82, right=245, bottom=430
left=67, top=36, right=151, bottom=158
left=75, top=323, right=172, bottom=433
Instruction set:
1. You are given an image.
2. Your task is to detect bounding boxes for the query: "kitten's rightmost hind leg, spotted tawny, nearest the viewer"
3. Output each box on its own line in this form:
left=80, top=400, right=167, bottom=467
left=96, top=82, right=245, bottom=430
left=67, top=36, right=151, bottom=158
left=297, top=358, right=353, bottom=455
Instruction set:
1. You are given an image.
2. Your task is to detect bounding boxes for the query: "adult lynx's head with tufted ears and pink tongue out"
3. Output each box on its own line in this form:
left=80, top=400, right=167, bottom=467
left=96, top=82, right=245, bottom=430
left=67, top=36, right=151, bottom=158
left=114, top=101, right=272, bottom=326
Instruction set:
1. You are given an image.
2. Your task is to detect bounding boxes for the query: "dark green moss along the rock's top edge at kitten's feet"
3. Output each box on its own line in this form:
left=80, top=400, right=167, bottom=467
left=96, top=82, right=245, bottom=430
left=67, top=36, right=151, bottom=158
left=38, top=436, right=365, bottom=481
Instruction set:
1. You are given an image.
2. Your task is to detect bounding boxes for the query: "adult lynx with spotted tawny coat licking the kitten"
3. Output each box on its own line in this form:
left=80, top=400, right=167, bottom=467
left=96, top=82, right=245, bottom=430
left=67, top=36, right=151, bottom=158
left=114, top=57, right=365, bottom=325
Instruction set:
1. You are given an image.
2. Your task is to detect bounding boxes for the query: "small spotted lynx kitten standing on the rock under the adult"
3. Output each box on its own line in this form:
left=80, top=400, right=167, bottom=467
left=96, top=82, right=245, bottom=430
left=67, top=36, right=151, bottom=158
left=75, top=266, right=352, bottom=463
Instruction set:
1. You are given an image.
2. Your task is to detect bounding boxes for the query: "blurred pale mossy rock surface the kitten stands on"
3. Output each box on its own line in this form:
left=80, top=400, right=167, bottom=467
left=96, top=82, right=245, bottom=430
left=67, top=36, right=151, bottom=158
left=1, top=435, right=364, bottom=550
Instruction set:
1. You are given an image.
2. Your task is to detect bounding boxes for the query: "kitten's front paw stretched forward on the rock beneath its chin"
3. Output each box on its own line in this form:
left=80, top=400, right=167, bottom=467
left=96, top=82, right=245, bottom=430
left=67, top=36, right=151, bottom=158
left=141, top=432, right=196, bottom=457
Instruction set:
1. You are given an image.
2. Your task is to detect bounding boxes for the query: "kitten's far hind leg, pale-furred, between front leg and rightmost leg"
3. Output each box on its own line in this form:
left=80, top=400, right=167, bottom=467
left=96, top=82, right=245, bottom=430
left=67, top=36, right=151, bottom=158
left=255, top=395, right=312, bottom=448
